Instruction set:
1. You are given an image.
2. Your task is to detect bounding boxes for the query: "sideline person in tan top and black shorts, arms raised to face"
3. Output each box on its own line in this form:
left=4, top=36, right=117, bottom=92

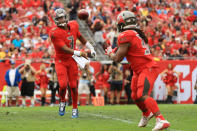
left=19, top=60, right=36, bottom=107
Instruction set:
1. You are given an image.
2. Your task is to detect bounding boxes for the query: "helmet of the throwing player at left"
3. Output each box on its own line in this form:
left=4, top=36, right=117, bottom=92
left=53, top=8, right=69, bottom=26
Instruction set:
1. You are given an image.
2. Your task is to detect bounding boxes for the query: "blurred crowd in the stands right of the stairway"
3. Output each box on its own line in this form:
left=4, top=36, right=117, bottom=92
left=81, top=0, right=197, bottom=59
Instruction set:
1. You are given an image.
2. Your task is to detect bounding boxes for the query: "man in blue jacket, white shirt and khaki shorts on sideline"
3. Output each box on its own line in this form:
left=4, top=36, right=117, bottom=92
left=5, top=61, right=21, bottom=106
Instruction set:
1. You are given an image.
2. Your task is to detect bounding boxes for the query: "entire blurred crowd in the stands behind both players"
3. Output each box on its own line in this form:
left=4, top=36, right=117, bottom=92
left=0, top=0, right=197, bottom=60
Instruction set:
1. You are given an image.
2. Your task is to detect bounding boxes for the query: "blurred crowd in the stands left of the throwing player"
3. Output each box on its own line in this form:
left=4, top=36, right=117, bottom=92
left=0, top=0, right=63, bottom=60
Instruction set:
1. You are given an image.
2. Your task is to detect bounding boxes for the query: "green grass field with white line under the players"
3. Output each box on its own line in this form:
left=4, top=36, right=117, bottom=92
left=0, top=104, right=197, bottom=131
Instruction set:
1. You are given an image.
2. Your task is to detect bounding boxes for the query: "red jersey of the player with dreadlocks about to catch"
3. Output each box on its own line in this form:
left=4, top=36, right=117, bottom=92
left=118, top=30, right=156, bottom=74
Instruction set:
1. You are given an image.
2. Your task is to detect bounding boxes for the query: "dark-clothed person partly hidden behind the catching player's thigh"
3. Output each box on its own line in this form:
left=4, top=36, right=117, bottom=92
left=124, top=69, right=133, bottom=104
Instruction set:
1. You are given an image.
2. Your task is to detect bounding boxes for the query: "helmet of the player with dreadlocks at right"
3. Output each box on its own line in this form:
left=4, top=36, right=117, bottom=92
left=116, top=11, right=137, bottom=32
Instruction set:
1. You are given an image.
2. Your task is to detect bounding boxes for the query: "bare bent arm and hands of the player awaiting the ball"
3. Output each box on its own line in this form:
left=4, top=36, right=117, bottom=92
left=106, top=43, right=130, bottom=62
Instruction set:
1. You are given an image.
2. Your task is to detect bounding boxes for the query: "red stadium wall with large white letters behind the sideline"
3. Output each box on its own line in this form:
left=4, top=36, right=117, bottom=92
left=0, top=60, right=197, bottom=104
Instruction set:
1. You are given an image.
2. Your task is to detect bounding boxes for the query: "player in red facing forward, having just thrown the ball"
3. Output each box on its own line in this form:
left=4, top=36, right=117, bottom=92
left=50, top=8, right=96, bottom=118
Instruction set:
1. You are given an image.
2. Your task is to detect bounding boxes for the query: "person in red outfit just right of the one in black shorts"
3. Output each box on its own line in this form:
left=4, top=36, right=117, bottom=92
left=36, top=64, right=49, bottom=106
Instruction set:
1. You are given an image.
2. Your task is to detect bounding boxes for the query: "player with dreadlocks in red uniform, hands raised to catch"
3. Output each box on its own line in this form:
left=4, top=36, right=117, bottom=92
left=106, top=11, right=170, bottom=131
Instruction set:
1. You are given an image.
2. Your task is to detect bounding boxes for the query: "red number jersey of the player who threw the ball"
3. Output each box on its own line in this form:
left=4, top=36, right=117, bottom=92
left=50, top=21, right=81, bottom=59
